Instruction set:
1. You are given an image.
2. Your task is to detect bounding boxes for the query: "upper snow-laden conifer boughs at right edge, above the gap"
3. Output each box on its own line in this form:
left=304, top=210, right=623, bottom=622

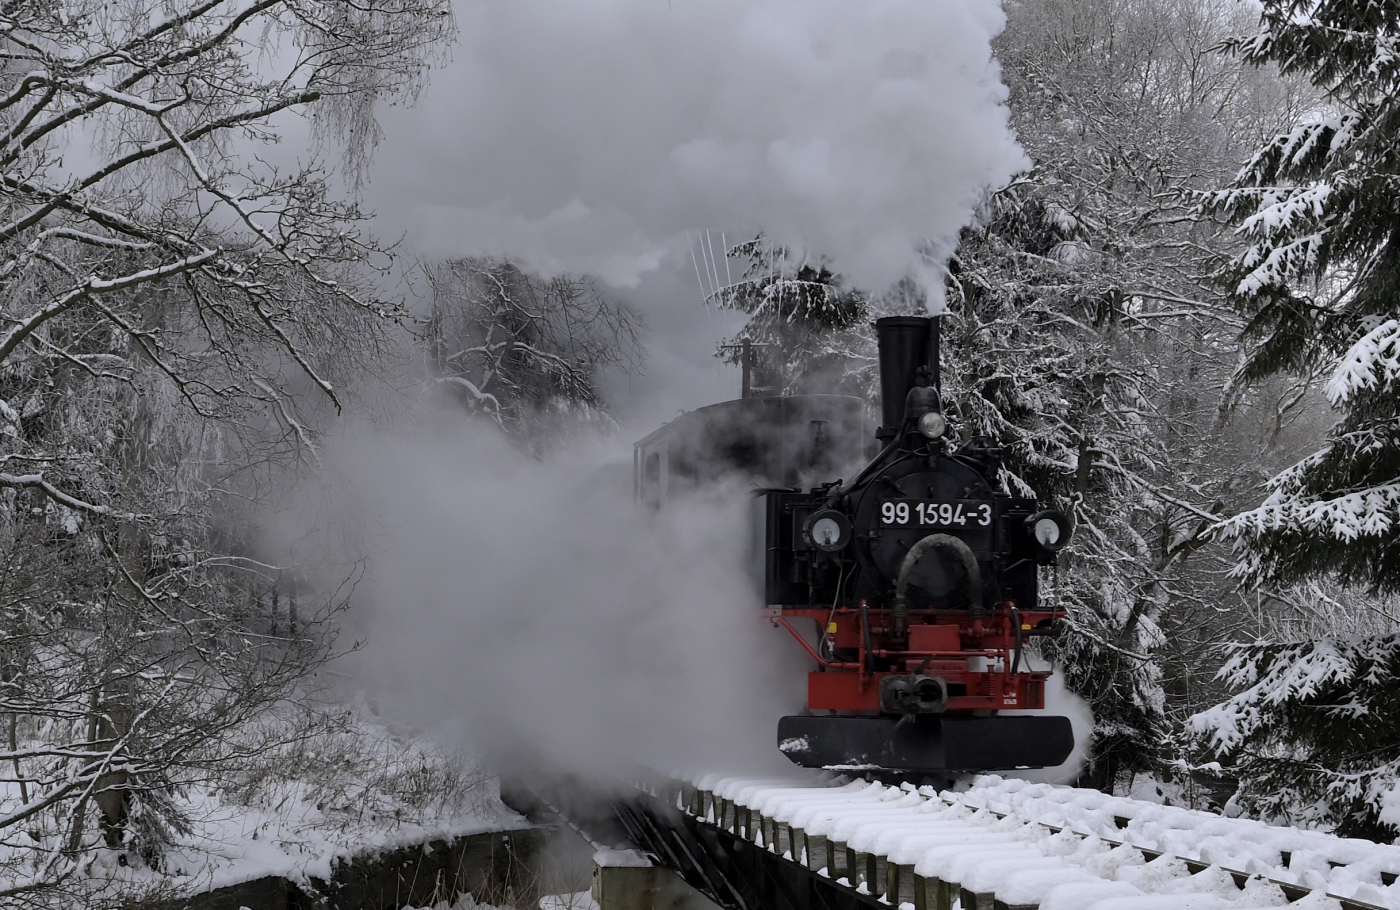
left=1205, top=0, right=1400, bottom=591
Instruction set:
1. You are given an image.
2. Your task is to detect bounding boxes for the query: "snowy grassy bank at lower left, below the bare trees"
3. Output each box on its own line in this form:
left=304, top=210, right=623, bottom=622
left=0, top=710, right=529, bottom=899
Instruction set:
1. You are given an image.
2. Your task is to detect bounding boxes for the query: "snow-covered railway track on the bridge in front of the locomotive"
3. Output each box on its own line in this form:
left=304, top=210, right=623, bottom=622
left=658, top=776, right=1400, bottom=910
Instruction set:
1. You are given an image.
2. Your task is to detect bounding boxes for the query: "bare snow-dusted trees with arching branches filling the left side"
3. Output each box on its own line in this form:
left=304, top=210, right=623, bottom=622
left=0, top=0, right=452, bottom=890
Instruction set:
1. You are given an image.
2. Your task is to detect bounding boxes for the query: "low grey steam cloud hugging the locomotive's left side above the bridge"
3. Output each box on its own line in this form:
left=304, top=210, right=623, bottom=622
left=329, top=424, right=805, bottom=777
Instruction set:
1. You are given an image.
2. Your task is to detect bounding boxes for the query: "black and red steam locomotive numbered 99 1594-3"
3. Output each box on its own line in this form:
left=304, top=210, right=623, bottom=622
left=634, top=316, right=1074, bottom=776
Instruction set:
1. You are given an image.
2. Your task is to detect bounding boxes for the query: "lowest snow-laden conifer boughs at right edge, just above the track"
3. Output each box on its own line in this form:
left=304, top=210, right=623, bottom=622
left=1187, top=634, right=1400, bottom=840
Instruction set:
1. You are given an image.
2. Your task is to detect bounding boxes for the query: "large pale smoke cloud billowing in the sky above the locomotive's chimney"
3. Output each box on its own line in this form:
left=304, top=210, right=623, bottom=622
left=370, top=0, right=1026, bottom=298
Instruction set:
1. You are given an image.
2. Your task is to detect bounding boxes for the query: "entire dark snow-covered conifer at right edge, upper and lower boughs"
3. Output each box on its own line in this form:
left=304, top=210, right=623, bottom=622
left=1191, top=0, right=1400, bottom=836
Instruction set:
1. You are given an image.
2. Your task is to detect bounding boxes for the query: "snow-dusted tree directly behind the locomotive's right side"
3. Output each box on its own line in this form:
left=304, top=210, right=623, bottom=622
left=944, top=183, right=1187, bottom=787
